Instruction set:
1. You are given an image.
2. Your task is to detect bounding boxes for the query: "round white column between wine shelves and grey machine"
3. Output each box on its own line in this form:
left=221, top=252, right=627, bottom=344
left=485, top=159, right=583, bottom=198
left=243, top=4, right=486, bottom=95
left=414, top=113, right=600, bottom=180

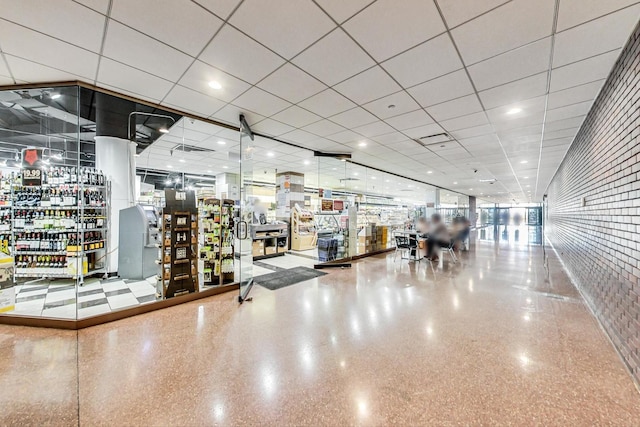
left=95, top=136, right=135, bottom=273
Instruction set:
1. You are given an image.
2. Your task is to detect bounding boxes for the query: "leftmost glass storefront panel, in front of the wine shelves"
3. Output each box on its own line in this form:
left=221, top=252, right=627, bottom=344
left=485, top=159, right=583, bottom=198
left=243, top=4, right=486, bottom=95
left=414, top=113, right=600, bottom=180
left=0, top=86, right=82, bottom=319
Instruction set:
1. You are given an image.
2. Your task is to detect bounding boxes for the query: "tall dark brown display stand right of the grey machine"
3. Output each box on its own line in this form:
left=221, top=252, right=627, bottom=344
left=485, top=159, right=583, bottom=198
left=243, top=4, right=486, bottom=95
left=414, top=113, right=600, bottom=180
left=158, top=190, right=199, bottom=298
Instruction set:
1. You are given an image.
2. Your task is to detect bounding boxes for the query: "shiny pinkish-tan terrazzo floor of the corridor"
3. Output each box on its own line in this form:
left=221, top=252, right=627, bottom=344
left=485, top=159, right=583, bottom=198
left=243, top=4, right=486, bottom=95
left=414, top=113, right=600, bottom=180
left=0, top=241, right=640, bottom=426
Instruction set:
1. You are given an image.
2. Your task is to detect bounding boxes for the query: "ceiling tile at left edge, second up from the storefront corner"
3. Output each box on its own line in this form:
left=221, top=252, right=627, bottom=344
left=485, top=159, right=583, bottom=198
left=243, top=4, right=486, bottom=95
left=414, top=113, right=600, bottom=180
left=0, top=20, right=98, bottom=82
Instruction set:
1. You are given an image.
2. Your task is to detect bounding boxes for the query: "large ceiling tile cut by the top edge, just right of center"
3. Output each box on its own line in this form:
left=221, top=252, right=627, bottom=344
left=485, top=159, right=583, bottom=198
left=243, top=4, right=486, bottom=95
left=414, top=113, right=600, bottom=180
left=343, top=0, right=445, bottom=62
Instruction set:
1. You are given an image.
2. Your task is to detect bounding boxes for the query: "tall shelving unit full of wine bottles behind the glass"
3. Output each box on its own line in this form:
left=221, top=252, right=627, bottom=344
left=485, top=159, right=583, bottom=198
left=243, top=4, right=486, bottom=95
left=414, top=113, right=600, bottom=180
left=11, top=167, right=110, bottom=285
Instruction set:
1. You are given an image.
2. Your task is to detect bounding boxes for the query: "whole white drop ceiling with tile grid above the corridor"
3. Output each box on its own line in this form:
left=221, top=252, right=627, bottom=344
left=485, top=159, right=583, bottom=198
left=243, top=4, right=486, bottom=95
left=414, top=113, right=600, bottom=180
left=0, top=0, right=640, bottom=200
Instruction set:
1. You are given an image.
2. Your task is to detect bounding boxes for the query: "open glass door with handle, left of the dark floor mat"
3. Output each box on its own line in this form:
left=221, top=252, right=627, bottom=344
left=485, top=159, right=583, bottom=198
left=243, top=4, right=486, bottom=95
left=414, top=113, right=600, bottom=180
left=236, top=119, right=254, bottom=302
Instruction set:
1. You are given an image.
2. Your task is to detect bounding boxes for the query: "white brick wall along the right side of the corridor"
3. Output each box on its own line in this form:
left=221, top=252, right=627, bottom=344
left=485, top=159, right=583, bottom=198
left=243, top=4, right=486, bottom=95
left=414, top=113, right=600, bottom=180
left=546, top=20, right=640, bottom=380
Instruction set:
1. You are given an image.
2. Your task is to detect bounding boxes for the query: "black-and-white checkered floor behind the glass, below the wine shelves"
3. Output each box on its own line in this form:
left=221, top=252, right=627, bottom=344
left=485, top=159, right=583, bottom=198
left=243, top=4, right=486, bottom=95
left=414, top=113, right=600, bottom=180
left=11, top=278, right=156, bottom=319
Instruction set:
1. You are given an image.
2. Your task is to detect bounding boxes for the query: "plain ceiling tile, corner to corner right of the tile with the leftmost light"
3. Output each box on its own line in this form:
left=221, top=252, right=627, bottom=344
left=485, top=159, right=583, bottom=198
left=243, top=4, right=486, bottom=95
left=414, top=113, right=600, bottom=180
left=258, top=63, right=327, bottom=104
